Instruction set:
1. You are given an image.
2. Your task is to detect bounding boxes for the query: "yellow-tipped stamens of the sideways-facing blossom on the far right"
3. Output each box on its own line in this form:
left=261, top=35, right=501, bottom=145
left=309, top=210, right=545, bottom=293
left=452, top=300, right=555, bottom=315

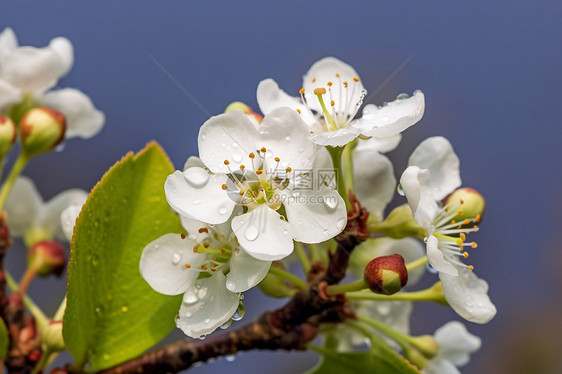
left=426, top=199, right=481, bottom=270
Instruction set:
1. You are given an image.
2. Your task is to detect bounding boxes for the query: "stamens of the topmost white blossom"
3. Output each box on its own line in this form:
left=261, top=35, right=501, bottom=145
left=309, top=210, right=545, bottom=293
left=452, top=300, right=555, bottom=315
left=297, top=73, right=367, bottom=132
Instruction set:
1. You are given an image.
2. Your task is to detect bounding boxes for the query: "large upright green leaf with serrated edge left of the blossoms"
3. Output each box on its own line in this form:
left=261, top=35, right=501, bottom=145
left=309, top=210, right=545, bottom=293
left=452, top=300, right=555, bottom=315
left=63, top=143, right=182, bottom=371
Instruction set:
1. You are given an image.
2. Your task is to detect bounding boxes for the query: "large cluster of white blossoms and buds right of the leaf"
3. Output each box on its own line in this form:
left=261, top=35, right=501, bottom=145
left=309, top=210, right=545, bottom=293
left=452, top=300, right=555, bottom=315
left=140, top=57, right=496, bottom=373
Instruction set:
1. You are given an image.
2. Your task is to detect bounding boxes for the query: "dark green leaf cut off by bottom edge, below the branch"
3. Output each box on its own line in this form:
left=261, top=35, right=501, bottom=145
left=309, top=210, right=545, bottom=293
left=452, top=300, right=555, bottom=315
left=305, top=347, right=420, bottom=374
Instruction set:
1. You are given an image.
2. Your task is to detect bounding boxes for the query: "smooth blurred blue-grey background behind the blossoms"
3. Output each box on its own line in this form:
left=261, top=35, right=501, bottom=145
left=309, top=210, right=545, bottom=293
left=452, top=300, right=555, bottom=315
left=0, top=0, right=562, bottom=374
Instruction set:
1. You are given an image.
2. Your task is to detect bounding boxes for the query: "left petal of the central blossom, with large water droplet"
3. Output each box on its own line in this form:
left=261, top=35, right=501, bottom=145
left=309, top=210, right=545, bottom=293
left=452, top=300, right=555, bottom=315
left=164, top=167, right=235, bottom=225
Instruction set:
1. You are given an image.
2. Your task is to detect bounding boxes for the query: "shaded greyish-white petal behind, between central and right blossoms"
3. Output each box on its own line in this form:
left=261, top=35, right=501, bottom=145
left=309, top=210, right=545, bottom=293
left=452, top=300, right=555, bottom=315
left=353, top=147, right=396, bottom=220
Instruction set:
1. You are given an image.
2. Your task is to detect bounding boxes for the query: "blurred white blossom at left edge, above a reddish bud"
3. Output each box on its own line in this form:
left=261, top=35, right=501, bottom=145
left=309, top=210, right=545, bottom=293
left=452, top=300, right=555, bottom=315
left=4, top=176, right=88, bottom=245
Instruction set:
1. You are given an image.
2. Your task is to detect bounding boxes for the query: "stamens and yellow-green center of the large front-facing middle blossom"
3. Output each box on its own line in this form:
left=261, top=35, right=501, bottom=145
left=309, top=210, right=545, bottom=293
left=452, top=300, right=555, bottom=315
left=222, top=147, right=293, bottom=210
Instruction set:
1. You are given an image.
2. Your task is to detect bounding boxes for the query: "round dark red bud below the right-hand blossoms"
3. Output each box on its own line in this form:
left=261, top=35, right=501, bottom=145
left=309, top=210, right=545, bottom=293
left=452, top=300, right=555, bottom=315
left=364, top=254, right=408, bottom=295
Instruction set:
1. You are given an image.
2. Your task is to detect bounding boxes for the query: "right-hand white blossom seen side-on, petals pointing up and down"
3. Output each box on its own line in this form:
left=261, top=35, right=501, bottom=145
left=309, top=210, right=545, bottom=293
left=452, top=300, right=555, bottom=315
left=400, top=137, right=497, bottom=323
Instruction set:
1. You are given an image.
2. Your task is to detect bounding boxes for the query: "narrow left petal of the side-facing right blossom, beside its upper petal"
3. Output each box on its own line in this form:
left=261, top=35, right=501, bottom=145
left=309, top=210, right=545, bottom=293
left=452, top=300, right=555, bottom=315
left=400, top=166, right=439, bottom=228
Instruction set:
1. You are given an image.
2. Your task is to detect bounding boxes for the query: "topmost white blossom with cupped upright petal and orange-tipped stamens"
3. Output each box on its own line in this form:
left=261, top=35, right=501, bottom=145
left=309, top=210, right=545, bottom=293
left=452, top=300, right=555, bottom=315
left=257, top=57, right=425, bottom=146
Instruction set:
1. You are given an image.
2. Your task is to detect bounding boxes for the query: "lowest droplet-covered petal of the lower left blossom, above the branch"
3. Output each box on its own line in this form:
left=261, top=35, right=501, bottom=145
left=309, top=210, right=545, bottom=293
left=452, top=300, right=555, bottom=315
left=176, top=271, right=236, bottom=338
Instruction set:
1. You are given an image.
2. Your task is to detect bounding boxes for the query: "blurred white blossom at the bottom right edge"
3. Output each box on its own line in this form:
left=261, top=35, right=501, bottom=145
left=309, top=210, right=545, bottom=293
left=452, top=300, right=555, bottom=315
left=423, top=321, right=481, bottom=374
